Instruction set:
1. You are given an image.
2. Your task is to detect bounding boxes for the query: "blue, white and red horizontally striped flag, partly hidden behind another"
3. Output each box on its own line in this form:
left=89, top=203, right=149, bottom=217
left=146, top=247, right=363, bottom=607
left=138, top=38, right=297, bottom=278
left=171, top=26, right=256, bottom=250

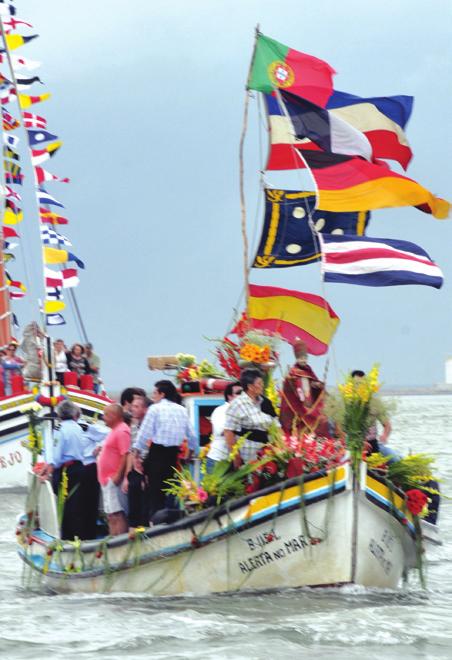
left=264, top=91, right=413, bottom=170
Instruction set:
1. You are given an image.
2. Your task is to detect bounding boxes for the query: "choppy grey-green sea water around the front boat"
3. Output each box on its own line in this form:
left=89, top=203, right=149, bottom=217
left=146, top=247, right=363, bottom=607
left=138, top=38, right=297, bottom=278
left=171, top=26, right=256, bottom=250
left=0, top=396, right=452, bottom=660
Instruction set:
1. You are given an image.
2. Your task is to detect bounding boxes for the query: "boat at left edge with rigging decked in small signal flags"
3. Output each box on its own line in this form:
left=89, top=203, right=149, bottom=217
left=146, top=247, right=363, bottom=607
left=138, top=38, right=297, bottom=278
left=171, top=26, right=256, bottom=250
left=0, top=5, right=111, bottom=488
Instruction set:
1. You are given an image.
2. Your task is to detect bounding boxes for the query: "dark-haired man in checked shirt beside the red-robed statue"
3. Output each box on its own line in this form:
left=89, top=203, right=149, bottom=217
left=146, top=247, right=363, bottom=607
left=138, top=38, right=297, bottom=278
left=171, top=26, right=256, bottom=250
left=224, top=369, right=275, bottom=467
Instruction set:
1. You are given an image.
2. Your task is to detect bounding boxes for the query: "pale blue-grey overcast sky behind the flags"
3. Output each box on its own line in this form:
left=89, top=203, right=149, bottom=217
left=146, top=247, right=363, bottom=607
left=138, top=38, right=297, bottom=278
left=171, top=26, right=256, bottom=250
left=11, top=0, right=452, bottom=390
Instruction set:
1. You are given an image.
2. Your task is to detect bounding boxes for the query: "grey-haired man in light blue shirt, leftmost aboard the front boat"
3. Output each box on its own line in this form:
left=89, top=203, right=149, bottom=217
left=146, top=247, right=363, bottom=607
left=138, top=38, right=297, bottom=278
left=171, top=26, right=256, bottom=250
left=46, top=400, right=86, bottom=540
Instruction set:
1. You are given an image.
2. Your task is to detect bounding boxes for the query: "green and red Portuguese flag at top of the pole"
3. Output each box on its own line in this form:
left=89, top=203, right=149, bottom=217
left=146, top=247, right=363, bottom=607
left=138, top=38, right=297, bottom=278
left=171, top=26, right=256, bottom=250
left=247, top=33, right=335, bottom=108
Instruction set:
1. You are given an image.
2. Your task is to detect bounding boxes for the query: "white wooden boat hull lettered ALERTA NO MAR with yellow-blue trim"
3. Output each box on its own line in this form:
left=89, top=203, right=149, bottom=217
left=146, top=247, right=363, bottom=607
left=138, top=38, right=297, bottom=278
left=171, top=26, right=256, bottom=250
left=17, top=463, right=417, bottom=596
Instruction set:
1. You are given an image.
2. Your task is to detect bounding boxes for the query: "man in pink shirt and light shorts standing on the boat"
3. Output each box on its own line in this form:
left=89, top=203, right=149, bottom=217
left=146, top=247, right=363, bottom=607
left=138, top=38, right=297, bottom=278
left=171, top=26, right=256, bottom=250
left=97, top=403, right=130, bottom=536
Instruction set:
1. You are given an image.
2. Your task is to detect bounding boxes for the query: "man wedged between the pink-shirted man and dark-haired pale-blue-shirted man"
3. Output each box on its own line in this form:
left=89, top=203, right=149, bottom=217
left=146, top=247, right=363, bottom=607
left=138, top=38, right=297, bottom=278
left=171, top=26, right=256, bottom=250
left=122, top=395, right=152, bottom=528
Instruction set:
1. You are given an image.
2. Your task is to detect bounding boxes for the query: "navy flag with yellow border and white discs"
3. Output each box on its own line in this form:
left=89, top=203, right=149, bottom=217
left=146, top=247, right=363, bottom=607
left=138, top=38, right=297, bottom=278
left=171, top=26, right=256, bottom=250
left=253, top=188, right=370, bottom=268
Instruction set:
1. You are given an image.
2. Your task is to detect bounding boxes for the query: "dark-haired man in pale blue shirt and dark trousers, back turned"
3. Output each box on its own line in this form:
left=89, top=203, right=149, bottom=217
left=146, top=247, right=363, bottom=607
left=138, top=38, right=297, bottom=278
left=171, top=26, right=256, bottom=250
left=135, top=380, right=197, bottom=520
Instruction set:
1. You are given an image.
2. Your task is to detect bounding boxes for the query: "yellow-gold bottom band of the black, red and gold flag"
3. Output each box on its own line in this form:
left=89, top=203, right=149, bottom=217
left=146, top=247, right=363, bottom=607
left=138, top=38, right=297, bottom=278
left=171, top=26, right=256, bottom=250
left=318, top=177, right=450, bottom=219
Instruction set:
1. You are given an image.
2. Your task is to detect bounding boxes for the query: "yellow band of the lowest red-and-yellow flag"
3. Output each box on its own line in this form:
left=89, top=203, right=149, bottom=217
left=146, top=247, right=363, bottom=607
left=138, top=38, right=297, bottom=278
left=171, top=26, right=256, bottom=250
left=248, top=296, right=339, bottom=344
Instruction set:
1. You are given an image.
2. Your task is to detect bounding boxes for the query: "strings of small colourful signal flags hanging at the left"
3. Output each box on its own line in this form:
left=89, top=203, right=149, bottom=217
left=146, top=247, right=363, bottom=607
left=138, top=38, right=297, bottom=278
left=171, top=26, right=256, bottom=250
left=0, top=0, right=85, bottom=325
